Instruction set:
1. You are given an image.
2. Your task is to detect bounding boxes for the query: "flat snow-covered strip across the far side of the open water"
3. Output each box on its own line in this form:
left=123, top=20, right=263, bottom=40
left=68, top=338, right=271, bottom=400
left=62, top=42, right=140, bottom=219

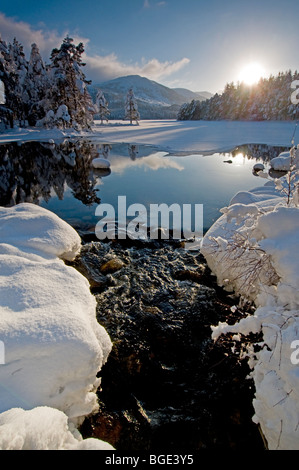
left=0, top=120, right=299, bottom=154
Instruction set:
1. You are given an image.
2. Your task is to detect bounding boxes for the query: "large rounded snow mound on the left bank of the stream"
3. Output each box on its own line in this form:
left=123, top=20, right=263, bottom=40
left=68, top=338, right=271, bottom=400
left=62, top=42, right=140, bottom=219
left=0, top=204, right=111, bottom=448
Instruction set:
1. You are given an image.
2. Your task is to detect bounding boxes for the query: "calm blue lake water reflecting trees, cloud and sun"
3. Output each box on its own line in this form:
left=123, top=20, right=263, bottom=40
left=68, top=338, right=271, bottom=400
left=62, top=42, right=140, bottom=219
left=0, top=139, right=286, bottom=235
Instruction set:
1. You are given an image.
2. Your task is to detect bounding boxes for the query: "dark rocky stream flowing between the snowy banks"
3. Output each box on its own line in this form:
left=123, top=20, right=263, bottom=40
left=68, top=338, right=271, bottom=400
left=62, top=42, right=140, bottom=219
left=69, top=240, right=263, bottom=453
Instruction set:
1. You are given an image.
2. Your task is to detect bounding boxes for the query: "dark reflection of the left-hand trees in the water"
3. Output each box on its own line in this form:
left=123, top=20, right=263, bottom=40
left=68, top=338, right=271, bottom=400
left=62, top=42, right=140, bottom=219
left=0, top=140, right=105, bottom=206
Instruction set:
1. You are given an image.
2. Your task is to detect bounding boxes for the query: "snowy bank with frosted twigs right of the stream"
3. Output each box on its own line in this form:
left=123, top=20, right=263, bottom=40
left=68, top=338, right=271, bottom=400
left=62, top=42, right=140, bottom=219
left=202, top=171, right=299, bottom=450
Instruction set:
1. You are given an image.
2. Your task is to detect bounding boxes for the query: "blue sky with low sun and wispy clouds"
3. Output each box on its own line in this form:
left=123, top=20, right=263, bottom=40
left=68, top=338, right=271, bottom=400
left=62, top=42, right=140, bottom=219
left=0, top=0, right=299, bottom=93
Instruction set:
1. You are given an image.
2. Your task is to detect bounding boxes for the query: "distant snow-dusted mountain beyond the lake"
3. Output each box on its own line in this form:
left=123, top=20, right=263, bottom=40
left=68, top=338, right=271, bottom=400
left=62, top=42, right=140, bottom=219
left=89, top=75, right=212, bottom=119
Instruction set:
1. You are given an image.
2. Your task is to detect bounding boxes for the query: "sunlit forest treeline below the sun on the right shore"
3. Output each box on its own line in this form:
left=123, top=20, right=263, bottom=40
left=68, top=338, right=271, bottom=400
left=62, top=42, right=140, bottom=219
left=177, top=71, right=299, bottom=121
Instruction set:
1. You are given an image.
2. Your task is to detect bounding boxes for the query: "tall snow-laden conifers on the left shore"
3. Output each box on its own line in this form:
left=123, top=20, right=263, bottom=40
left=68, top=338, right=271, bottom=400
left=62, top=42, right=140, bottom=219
left=0, top=36, right=97, bottom=129
